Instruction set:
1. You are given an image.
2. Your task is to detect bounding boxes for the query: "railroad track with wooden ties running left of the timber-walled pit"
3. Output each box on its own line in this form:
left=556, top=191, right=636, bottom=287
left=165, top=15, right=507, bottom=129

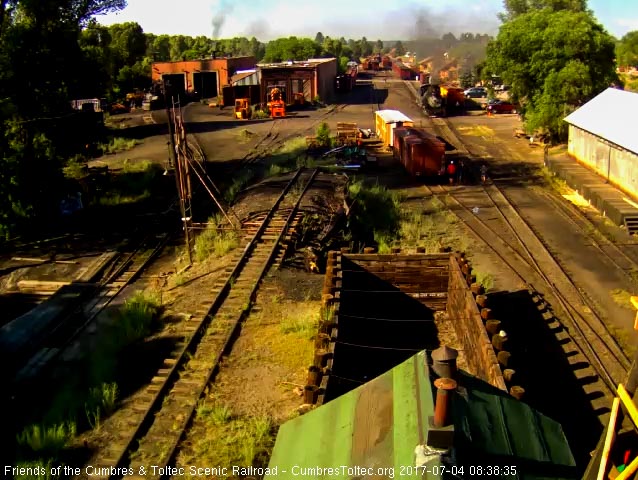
left=76, top=169, right=318, bottom=479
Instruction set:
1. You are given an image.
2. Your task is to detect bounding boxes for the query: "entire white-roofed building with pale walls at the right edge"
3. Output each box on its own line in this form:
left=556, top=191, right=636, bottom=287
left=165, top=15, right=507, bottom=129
left=565, top=88, right=638, bottom=198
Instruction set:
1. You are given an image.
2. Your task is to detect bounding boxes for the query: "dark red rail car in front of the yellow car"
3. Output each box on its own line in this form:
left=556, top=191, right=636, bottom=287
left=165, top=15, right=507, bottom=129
left=393, top=127, right=445, bottom=180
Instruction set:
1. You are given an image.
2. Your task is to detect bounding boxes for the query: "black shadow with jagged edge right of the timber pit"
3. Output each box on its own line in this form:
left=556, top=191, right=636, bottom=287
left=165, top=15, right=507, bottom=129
left=489, top=290, right=603, bottom=471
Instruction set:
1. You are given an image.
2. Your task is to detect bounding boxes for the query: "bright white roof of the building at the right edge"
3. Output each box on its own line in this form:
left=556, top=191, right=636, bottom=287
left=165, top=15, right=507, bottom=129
left=565, top=88, right=638, bottom=154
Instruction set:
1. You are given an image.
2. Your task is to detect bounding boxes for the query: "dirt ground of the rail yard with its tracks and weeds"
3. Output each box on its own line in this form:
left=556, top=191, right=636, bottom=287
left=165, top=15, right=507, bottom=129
left=0, top=67, right=638, bottom=478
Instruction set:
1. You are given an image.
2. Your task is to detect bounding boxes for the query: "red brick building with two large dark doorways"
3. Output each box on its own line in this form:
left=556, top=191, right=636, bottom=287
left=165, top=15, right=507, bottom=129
left=151, top=57, right=255, bottom=98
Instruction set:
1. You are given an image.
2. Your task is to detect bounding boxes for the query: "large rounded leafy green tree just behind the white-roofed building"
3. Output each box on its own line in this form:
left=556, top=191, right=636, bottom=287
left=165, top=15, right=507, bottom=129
left=484, top=9, right=617, bottom=137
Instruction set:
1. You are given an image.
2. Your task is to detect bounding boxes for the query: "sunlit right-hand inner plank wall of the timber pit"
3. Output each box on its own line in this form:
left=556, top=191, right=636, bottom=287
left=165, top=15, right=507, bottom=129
left=447, top=254, right=507, bottom=391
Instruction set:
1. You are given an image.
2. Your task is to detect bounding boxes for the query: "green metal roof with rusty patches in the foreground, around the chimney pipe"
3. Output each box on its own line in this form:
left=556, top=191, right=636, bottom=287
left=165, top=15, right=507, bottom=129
left=267, top=352, right=577, bottom=480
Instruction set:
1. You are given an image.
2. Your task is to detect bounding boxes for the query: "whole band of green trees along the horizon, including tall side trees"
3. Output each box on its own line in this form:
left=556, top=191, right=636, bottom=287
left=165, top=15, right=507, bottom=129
left=0, top=0, right=638, bottom=238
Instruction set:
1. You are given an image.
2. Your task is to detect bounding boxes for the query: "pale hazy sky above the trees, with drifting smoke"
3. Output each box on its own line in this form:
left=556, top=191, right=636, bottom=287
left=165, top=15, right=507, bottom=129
left=97, top=0, right=638, bottom=41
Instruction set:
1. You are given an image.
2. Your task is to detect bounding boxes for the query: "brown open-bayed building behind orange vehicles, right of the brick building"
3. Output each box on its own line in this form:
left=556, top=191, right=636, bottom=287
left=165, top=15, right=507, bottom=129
left=257, top=58, right=337, bottom=104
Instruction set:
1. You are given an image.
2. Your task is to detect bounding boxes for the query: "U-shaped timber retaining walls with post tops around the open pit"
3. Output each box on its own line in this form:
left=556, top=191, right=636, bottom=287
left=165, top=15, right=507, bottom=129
left=304, top=249, right=524, bottom=406
